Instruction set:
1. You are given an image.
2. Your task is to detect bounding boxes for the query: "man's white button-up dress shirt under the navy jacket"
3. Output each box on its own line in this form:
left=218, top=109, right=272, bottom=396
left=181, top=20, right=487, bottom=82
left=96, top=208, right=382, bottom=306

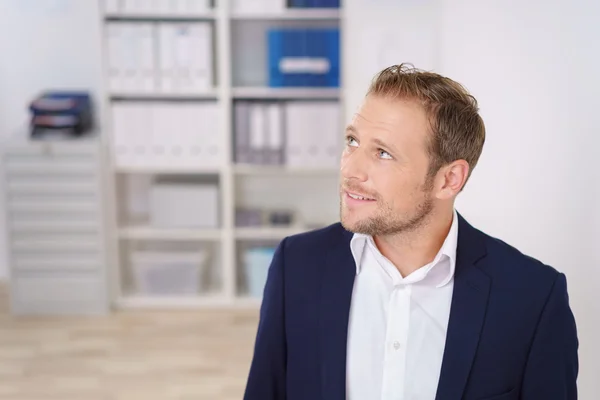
left=346, top=211, right=458, bottom=400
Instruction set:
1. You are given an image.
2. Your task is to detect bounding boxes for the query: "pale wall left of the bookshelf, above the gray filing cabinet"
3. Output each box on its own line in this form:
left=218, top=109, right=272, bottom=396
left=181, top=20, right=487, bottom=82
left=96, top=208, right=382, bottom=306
left=0, top=0, right=102, bottom=280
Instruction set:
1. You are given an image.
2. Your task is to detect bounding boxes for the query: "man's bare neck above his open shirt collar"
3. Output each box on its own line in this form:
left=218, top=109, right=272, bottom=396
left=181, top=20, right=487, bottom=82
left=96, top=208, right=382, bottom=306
left=373, top=209, right=454, bottom=277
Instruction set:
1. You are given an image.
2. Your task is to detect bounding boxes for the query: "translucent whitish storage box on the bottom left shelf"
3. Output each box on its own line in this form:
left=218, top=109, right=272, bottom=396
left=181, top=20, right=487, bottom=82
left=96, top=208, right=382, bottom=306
left=131, top=251, right=207, bottom=296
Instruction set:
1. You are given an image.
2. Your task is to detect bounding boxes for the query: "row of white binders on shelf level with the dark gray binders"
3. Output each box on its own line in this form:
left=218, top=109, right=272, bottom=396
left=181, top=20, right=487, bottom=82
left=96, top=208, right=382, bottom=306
left=112, top=101, right=224, bottom=169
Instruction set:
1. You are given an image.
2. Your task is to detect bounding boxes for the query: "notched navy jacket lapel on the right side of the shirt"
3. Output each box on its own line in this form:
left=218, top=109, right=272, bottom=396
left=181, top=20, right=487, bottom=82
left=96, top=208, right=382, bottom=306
left=436, top=215, right=490, bottom=400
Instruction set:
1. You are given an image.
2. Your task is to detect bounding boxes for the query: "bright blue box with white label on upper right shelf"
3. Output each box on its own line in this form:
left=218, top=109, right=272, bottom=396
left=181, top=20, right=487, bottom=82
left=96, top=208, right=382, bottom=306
left=267, top=28, right=340, bottom=87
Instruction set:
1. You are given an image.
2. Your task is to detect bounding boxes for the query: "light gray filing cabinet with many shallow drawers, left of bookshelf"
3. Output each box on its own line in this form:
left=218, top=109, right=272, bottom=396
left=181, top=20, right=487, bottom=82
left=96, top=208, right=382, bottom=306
left=2, top=138, right=109, bottom=315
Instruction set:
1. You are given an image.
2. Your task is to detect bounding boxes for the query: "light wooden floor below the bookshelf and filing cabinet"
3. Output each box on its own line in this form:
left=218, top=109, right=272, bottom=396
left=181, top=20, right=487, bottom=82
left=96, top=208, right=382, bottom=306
left=0, top=294, right=258, bottom=400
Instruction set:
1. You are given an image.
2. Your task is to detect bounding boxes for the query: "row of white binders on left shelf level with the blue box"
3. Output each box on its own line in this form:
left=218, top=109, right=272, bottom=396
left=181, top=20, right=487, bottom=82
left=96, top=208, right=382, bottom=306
left=107, top=22, right=213, bottom=93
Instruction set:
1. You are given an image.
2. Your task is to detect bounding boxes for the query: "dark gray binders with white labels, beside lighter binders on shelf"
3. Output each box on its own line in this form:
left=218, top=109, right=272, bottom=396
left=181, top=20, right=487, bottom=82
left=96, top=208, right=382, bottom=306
left=234, top=101, right=284, bottom=165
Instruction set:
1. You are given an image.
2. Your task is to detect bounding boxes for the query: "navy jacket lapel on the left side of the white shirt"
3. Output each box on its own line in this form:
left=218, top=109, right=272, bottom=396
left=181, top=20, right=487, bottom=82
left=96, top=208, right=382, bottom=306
left=319, top=225, right=356, bottom=400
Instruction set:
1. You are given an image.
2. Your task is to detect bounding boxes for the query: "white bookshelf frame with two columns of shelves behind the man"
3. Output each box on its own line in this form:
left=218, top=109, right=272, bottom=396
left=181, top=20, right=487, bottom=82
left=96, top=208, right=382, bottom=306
left=98, top=0, right=343, bottom=309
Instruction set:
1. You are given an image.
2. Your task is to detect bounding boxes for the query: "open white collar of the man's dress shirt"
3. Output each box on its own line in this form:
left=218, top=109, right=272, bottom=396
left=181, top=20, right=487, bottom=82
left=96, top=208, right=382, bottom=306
left=350, top=210, right=458, bottom=287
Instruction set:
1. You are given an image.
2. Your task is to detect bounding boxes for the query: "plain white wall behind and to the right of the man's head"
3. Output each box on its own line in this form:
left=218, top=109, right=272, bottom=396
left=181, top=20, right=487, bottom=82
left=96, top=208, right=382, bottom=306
left=344, top=0, right=600, bottom=399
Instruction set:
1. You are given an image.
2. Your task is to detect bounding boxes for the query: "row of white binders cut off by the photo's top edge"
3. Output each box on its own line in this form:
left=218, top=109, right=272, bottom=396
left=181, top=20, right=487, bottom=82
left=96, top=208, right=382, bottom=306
left=104, top=0, right=212, bottom=16
